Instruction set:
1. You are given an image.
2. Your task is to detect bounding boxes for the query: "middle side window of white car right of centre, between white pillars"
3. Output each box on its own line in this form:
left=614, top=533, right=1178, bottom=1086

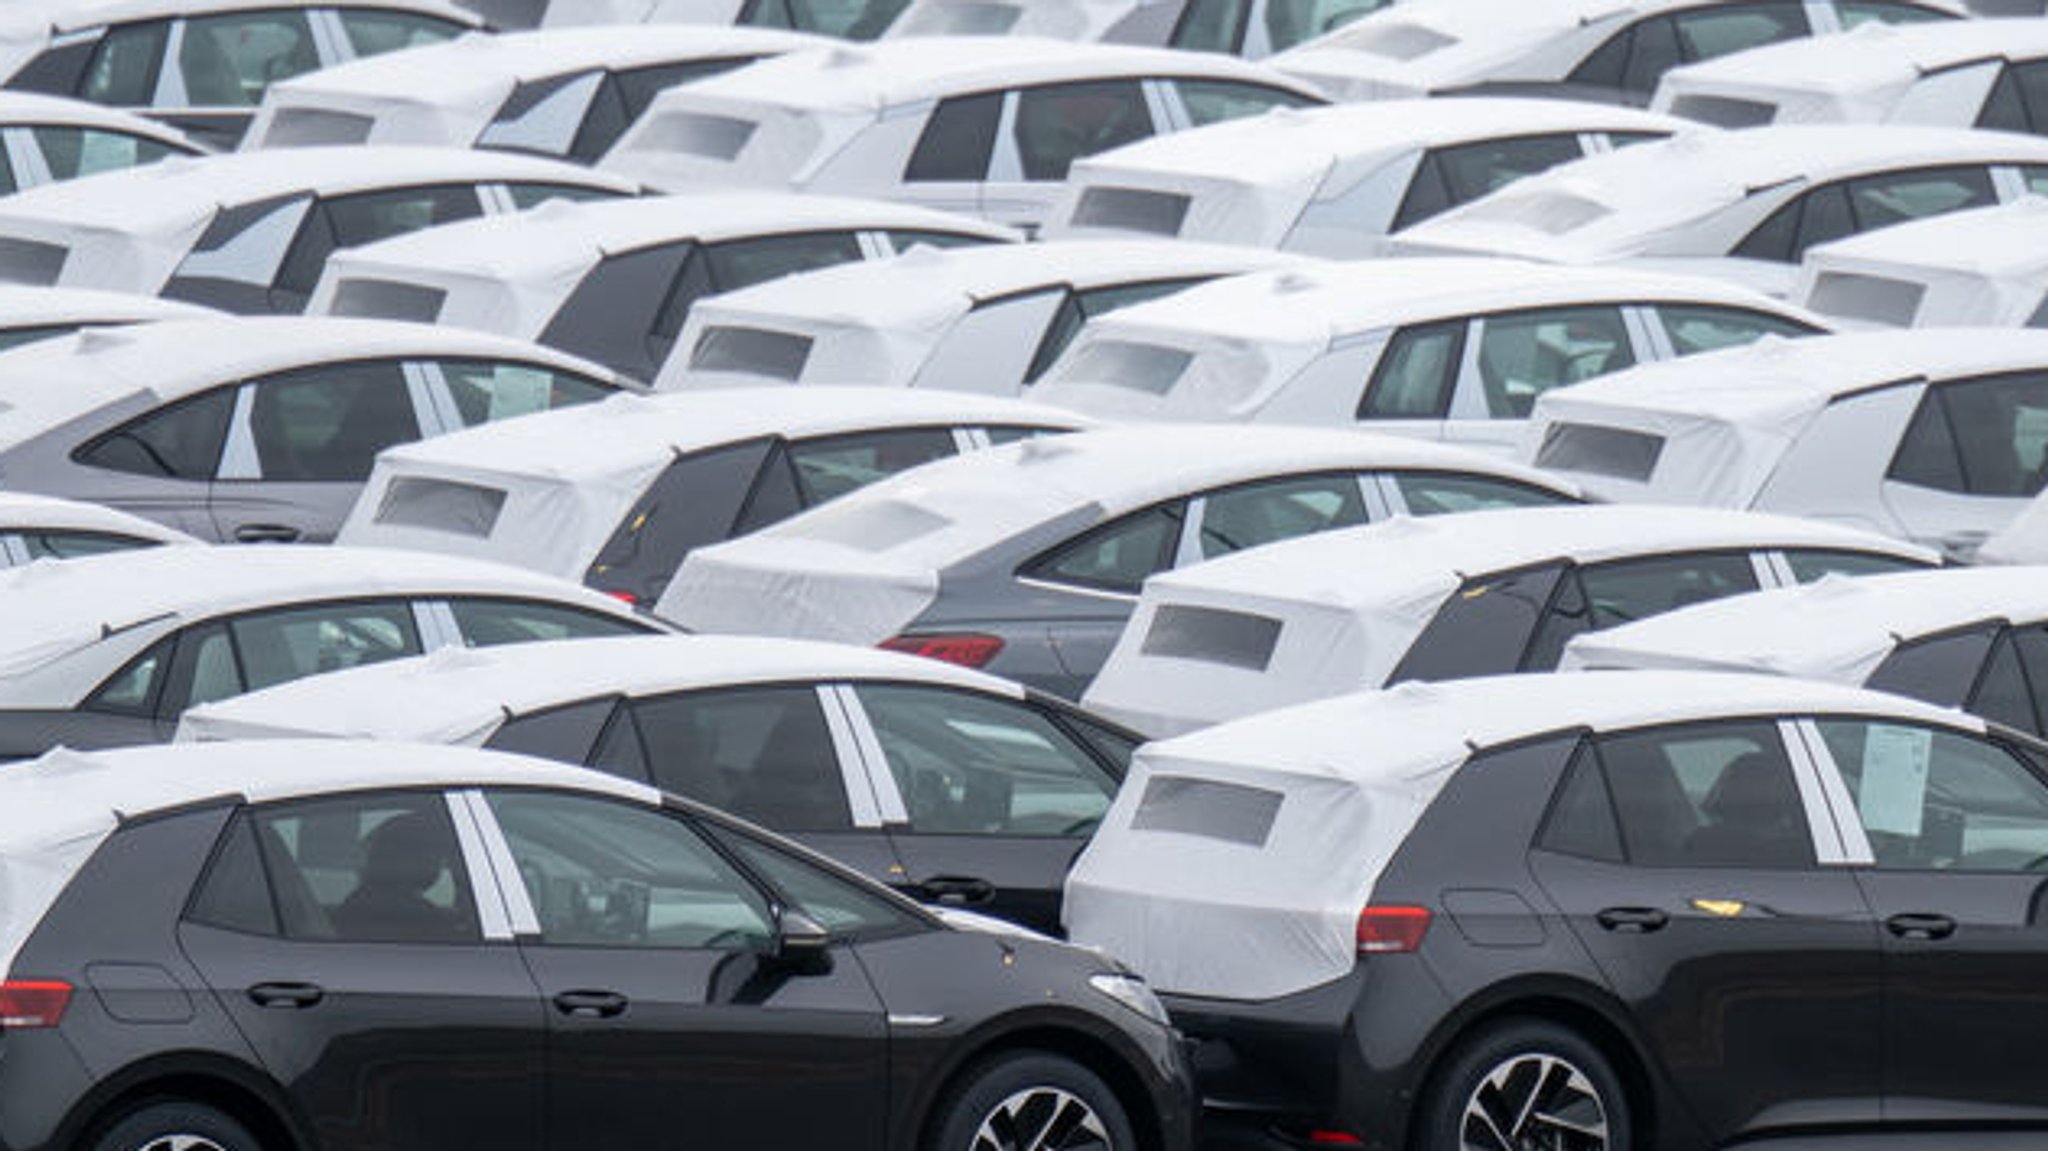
left=1479, top=307, right=1636, bottom=420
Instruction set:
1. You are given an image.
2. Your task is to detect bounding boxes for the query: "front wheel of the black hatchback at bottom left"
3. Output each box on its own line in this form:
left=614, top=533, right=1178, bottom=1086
left=924, top=1051, right=1137, bottom=1151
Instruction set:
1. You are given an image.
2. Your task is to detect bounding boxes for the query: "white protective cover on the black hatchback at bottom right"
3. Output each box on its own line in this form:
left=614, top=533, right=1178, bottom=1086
left=1063, top=672, right=1982, bottom=999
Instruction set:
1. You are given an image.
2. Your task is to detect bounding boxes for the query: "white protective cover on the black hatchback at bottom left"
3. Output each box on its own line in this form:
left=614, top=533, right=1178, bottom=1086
left=0, top=741, right=662, bottom=979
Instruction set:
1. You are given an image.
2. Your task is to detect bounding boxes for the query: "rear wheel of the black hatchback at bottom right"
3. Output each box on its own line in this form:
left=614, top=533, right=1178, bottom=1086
left=1411, top=1020, right=1634, bottom=1151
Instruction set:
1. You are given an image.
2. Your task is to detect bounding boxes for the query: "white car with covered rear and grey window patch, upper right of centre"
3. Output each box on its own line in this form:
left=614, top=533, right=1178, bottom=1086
left=1040, top=96, right=1698, bottom=258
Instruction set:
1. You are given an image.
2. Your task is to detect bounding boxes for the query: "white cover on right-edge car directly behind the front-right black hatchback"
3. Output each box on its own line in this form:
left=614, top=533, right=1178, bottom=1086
left=1559, top=567, right=2048, bottom=679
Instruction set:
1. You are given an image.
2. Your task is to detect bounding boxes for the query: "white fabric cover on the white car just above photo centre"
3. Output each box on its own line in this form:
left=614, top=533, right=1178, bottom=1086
left=671, top=240, right=1317, bottom=395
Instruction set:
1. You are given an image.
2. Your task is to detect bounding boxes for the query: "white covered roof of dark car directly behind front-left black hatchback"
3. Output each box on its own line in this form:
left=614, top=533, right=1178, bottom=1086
left=178, top=635, right=1024, bottom=745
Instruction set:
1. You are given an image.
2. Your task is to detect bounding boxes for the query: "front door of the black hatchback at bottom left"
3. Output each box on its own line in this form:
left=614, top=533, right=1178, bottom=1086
left=477, top=788, right=891, bottom=1151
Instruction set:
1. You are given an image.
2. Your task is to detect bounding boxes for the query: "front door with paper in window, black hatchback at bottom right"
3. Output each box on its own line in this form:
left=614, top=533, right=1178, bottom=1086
left=1808, top=717, right=2048, bottom=1124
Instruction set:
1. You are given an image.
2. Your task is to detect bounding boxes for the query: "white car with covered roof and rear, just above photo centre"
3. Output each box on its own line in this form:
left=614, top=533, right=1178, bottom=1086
left=671, top=240, right=1307, bottom=395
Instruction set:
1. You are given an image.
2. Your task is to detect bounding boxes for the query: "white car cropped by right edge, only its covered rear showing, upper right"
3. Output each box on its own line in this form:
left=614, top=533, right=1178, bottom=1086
left=1792, top=197, right=2048, bottom=328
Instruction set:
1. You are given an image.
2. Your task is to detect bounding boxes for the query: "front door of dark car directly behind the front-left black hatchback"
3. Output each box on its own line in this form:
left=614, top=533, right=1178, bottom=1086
left=842, top=682, right=1128, bottom=934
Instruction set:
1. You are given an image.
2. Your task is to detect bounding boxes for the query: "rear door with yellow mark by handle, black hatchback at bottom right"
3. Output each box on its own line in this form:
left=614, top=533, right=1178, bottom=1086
left=1530, top=719, right=1882, bottom=1145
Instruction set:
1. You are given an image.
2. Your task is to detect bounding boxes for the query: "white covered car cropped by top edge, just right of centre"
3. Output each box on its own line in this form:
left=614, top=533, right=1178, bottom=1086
left=889, top=0, right=1395, bottom=59
